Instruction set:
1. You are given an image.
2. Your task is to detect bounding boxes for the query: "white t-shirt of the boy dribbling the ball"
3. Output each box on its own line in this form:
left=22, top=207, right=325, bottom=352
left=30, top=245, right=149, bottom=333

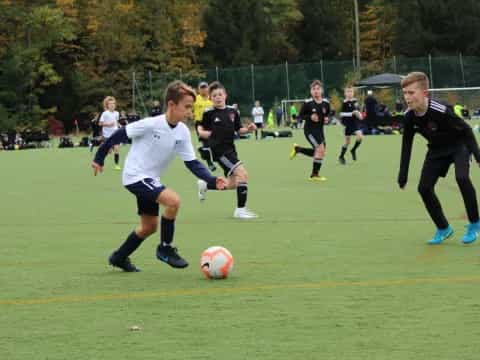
left=122, top=115, right=195, bottom=185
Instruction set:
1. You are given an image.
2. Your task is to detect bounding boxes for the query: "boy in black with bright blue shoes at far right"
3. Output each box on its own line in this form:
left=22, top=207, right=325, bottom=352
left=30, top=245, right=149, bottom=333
left=398, top=72, right=480, bottom=245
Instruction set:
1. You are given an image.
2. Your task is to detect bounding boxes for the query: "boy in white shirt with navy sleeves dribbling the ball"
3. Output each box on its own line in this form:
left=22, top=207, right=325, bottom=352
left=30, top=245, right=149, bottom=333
left=92, top=81, right=226, bottom=272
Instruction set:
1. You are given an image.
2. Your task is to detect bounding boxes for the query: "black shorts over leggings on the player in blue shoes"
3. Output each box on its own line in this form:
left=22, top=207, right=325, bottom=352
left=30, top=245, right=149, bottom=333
left=421, top=145, right=471, bottom=180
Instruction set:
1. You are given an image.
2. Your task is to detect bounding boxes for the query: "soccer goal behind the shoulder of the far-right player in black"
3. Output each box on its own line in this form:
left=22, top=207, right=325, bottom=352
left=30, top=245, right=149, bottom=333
left=429, top=86, right=480, bottom=119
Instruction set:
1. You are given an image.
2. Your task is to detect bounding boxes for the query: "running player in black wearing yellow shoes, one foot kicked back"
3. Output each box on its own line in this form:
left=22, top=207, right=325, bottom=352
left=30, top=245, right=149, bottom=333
left=290, top=80, right=330, bottom=181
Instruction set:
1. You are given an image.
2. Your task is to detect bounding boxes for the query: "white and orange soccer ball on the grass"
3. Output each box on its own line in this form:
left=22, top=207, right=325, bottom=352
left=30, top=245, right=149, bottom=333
left=200, top=246, right=233, bottom=279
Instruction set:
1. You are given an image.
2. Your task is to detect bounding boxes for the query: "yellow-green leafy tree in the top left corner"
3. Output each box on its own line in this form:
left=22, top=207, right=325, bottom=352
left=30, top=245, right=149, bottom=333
left=0, top=1, right=75, bottom=128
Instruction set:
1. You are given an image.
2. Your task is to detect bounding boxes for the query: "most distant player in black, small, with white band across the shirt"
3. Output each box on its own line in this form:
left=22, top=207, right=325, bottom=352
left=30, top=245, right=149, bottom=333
left=338, top=86, right=363, bottom=165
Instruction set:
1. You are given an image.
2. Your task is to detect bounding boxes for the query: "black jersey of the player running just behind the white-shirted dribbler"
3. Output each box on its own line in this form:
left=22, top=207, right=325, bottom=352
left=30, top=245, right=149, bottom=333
left=200, top=106, right=242, bottom=152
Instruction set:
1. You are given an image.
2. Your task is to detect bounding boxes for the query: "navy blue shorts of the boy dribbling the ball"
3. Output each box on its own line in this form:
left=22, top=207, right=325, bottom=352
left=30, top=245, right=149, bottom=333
left=125, top=178, right=165, bottom=216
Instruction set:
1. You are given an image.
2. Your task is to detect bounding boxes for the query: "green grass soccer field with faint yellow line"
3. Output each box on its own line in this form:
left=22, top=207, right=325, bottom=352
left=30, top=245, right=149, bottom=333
left=0, top=127, right=480, bottom=360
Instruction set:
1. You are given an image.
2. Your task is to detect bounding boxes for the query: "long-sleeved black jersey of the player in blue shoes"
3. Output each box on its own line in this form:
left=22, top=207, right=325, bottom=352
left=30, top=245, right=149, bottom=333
left=399, top=99, right=480, bottom=180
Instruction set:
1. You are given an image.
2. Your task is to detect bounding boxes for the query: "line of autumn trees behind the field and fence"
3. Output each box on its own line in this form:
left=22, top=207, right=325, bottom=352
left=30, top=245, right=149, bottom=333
left=0, top=0, right=480, bottom=128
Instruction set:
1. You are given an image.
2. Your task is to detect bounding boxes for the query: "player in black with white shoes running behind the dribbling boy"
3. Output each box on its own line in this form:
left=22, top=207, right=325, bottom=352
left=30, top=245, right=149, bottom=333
left=197, top=81, right=257, bottom=219
